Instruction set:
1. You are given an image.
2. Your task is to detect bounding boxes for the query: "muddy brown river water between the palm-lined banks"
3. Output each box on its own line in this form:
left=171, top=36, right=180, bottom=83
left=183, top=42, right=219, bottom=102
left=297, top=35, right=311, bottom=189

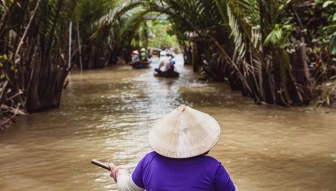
left=0, top=54, right=336, bottom=191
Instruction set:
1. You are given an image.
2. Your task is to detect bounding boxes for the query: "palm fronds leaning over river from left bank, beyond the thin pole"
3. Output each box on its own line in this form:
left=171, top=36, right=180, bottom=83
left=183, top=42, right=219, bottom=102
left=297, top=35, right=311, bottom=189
left=73, top=0, right=145, bottom=68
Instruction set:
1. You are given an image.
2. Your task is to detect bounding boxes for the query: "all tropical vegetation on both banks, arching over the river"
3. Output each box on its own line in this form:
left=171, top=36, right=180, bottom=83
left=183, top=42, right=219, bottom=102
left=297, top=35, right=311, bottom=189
left=0, top=0, right=336, bottom=128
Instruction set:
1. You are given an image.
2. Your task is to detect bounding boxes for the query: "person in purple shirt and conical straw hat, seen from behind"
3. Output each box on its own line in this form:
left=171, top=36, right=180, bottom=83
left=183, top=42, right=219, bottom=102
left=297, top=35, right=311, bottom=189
left=110, top=105, right=238, bottom=191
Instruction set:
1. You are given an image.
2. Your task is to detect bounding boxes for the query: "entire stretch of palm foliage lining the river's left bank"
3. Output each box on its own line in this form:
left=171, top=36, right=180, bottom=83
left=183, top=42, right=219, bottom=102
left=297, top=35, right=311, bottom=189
left=0, top=0, right=144, bottom=129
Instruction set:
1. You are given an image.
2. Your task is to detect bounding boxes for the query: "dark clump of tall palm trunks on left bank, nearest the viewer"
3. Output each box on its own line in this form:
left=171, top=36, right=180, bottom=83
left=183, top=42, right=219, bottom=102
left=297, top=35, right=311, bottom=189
left=0, top=0, right=77, bottom=127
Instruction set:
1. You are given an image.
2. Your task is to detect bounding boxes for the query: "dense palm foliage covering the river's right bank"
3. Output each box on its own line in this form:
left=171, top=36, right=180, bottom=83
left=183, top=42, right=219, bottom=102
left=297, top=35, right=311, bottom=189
left=144, top=0, right=336, bottom=105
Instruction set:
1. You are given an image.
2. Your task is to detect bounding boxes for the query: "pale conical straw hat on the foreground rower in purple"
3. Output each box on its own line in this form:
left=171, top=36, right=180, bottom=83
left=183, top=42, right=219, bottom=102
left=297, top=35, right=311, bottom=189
left=149, top=105, right=220, bottom=158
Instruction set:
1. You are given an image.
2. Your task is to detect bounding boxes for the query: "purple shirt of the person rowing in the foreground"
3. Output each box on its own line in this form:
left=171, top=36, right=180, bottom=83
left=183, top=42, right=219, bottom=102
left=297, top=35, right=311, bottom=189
left=132, top=152, right=235, bottom=191
